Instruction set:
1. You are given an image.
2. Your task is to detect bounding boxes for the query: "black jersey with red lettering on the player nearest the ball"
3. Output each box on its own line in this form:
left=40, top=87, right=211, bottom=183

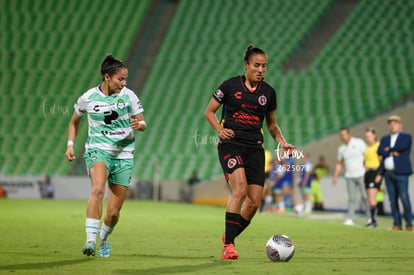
left=213, top=75, right=277, bottom=146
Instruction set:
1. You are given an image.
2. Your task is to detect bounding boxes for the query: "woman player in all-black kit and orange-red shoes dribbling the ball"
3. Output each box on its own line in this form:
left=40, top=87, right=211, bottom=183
left=205, top=46, right=295, bottom=260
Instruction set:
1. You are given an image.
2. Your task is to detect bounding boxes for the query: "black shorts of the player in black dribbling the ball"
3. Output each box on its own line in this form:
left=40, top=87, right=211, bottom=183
left=218, top=143, right=265, bottom=186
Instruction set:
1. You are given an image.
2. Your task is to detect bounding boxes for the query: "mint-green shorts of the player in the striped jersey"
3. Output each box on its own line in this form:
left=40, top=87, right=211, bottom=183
left=83, top=149, right=133, bottom=187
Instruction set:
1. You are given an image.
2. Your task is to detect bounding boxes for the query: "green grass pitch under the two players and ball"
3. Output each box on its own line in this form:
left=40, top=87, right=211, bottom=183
left=0, top=200, right=414, bottom=274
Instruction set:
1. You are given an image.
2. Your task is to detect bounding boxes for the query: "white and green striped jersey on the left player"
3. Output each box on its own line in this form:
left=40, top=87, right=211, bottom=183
left=74, top=86, right=144, bottom=159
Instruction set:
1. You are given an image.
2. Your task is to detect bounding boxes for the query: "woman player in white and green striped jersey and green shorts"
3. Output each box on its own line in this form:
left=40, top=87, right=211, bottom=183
left=65, top=55, right=146, bottom=257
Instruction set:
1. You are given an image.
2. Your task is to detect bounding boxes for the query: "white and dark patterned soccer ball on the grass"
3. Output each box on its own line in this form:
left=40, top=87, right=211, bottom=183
left=265, top=235, right=295, bottom=262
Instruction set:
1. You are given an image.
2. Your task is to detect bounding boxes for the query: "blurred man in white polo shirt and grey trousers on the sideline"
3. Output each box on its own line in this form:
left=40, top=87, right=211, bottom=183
left=332, top=128, right=369, bottom=225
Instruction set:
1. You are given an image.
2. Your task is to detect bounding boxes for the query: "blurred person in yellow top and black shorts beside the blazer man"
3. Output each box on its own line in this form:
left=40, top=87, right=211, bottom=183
left=364, top=127, right=381, bottom=227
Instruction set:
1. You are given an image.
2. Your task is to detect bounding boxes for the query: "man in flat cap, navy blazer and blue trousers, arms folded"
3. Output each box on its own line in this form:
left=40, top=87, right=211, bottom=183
left=375, top=115, right=413, bottom=232
